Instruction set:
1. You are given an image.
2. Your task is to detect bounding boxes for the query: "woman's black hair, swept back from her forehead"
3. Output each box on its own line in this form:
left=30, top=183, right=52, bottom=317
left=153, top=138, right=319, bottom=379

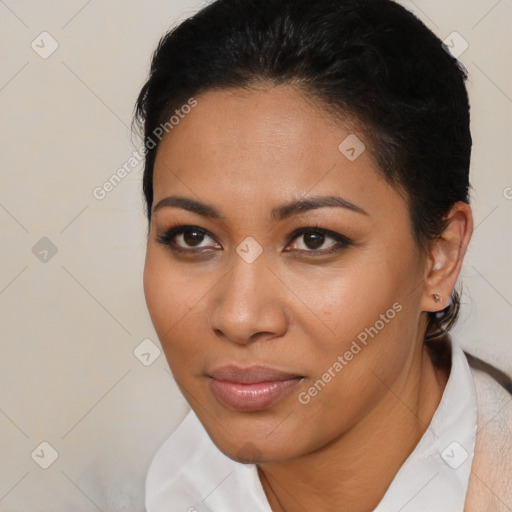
left=134, top=0, right=471, bottom=364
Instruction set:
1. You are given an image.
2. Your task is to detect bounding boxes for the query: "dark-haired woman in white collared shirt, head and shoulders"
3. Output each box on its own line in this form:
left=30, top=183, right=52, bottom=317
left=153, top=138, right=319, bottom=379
left=137, top=0, right=512, bottom=512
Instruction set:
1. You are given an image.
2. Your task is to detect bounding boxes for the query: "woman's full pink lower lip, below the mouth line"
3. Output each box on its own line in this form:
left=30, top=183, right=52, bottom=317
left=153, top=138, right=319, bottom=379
left=209, top=377, right=302, bottom=412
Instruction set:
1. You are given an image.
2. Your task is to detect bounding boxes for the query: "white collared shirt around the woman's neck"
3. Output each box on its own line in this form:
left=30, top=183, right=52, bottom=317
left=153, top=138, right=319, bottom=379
left=145, top=341, right=477, bottom=512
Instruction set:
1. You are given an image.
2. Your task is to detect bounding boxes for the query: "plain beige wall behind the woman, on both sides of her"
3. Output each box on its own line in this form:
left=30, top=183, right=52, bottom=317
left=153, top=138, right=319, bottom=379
left=0, top=0, right=512, bottom=512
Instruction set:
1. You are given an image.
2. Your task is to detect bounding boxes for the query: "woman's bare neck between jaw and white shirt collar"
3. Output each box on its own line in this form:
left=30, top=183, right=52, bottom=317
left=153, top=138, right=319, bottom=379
left=258, top=345, right=449, bottom=512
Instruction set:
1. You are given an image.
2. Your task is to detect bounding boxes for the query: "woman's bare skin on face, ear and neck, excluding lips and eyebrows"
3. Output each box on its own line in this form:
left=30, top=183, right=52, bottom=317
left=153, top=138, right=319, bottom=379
left=144, top=85, right=473, bottom=512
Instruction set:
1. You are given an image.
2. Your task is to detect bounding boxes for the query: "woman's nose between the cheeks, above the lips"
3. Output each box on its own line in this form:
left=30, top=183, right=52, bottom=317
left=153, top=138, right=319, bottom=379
left=208, top=256, right=288, bottom=345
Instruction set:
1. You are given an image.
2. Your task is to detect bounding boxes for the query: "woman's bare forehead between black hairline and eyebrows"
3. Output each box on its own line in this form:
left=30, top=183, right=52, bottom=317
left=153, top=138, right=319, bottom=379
left=154, top=86, right=404, bottom=218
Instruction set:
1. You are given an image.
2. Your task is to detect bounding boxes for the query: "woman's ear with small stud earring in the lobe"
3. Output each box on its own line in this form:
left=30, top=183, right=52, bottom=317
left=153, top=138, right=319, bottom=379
left=421, top=201, right=473, bottom=312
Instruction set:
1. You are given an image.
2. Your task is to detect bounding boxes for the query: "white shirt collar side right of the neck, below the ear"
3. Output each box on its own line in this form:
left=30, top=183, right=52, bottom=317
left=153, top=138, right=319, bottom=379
left=374, top=341, right=477, bottom=512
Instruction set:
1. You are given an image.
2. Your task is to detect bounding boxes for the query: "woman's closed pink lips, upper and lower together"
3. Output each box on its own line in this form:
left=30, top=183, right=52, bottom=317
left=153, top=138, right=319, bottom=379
left=208, top=366, right=304, bottom=412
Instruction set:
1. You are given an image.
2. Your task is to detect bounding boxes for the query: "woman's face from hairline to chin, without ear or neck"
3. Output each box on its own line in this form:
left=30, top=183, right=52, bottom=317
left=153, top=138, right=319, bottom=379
left=144, top=86, right=426, bottom=462
